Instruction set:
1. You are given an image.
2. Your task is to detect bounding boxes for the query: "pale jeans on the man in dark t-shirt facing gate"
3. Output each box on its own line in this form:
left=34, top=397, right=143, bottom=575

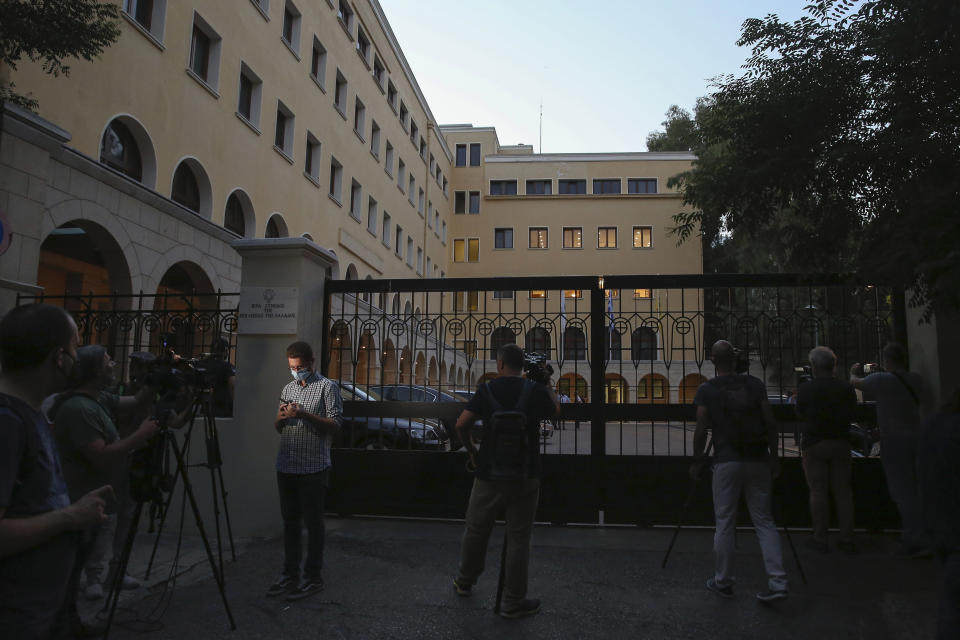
left=713, top=461, right=788, bottom=591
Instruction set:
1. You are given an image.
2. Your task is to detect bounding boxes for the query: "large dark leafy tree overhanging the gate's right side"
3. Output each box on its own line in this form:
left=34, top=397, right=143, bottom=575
left=671, top=0, right=960, bottom=314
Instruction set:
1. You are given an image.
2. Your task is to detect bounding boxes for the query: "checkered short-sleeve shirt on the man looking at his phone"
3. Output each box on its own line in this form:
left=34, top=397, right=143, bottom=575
left=276, top=372, right=343, bottom=474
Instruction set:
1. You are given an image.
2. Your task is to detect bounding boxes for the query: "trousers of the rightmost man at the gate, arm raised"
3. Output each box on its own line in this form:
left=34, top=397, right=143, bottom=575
left=880, top=435, right=926, bottom=547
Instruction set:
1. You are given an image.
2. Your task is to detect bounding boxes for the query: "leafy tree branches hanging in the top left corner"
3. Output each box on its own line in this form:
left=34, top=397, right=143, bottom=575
left=0, top=0, right=120, bottom=109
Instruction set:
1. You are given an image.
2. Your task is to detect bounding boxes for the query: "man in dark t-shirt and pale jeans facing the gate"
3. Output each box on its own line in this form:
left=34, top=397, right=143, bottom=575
left=690, top=340, right=789, bottom=602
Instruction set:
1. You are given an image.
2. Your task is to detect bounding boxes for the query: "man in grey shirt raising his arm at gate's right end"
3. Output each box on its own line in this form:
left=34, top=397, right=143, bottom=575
left=850, top=342, right=932, bottom=558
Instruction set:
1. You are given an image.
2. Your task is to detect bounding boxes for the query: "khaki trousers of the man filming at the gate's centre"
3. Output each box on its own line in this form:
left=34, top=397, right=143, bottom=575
left=457, top=478, right=540, bottom=609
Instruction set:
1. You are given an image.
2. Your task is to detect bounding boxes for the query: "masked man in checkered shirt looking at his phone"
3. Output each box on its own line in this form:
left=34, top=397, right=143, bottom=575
left=267, top=341, right=343, bottom=600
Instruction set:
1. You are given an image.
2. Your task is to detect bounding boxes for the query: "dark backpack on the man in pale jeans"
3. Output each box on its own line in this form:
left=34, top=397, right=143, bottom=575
left=708, top=375, right=768, bottom=457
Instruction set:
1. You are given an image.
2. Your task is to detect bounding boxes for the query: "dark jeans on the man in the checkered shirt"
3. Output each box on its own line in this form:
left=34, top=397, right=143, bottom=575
left=277, top=471, right=329, bottom=580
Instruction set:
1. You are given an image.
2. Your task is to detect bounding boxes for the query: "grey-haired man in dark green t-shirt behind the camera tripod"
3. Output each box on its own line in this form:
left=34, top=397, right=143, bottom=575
left=50, top=345, right=158, bottom=599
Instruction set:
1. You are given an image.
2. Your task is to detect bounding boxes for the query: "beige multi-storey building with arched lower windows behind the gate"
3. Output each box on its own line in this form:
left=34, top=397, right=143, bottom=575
left=0, top=0, right=702, bottom=402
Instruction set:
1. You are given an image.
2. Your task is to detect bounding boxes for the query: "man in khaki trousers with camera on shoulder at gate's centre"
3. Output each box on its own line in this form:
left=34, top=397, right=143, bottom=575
left=453, top=344, right=560, bottom=618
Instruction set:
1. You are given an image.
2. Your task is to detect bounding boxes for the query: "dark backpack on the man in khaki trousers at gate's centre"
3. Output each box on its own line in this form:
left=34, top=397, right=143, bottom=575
left=481, top=380, right=534, bottom=480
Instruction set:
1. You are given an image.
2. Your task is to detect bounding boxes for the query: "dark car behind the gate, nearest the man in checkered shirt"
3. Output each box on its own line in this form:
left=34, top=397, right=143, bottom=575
left=333, top=382, right=449, bottom=449
